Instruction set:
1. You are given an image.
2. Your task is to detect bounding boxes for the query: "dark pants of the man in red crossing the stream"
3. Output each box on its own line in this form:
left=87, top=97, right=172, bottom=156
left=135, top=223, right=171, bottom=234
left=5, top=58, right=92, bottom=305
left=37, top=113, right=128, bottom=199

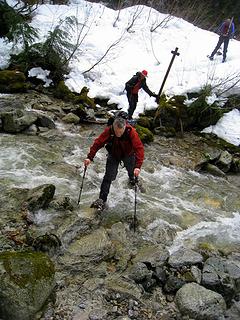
left=99, top=154, right=135, bottom=202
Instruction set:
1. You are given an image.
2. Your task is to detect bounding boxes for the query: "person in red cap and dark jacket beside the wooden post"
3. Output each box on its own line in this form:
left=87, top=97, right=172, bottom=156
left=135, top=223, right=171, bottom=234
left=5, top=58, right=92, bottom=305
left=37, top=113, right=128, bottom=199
left=125, top=70, right=157, bottom=119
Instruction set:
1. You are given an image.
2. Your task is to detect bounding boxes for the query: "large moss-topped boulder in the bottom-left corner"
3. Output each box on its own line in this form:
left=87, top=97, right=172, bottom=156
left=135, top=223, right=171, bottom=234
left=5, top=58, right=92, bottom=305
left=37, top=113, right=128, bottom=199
left=0, top=251, right=55, bottom=320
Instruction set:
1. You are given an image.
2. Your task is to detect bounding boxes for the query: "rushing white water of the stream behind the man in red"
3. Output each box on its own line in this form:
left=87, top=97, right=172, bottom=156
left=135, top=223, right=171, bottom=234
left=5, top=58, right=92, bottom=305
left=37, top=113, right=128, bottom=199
left=0, top=120, right=240, bottom=255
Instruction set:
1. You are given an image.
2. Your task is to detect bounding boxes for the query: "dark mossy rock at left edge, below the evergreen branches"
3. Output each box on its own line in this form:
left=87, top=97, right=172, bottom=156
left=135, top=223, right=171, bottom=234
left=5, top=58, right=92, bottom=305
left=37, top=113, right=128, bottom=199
left=0, top=70, right=29, bottom=93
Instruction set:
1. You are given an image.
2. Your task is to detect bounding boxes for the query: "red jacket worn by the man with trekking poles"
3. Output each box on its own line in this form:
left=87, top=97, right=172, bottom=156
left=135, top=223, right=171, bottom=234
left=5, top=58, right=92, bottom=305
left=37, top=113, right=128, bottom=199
left=87, top=124, right=144, bottom=169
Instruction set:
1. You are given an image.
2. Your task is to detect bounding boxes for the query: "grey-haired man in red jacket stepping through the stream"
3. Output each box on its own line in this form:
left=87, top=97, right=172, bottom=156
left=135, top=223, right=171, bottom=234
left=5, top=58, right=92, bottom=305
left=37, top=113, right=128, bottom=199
left=84, top=115, right=144, bottom=210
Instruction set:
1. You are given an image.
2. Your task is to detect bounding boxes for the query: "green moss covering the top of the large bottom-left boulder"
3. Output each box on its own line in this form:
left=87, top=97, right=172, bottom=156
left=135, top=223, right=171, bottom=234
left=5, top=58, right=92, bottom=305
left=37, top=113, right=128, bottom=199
left=0, top=251, right=55, bottom=288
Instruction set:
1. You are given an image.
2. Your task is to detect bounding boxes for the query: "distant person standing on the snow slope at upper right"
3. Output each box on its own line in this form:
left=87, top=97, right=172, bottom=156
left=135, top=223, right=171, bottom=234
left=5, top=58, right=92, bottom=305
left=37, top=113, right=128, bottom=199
left=209, top=18, right=235, bottom=62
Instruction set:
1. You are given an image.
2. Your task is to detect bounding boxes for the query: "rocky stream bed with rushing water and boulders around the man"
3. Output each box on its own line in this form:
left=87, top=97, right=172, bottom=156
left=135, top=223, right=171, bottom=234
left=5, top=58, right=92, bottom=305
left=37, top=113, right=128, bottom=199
left=0, top=92, right=240, bottom=320
